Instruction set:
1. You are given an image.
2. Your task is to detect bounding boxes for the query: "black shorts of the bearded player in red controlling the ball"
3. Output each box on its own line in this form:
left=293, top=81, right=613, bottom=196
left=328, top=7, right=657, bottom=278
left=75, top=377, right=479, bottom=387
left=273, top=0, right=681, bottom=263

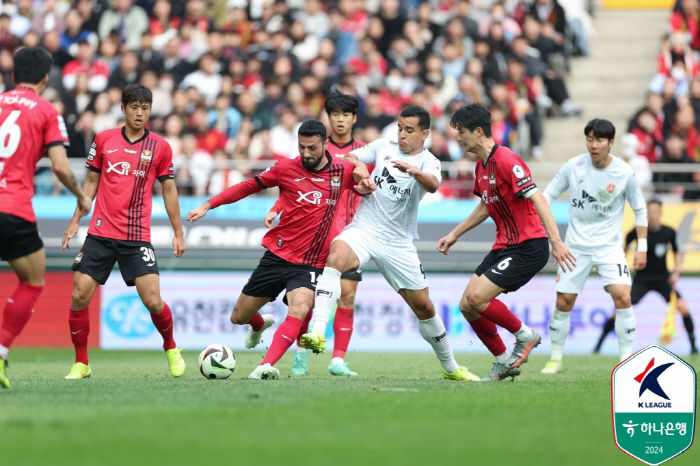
left=242, top=251, right=323, bottom=301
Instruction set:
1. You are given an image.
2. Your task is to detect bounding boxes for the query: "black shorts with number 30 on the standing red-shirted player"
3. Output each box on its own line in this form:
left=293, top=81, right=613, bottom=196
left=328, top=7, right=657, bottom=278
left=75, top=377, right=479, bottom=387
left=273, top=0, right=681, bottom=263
left=70, top=235, right=158, bottom=286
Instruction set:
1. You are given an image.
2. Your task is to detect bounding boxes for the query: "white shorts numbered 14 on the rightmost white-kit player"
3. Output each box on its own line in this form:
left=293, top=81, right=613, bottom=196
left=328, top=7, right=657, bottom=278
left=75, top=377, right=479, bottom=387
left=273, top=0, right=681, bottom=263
left=556, top=248, right=632, bottom=294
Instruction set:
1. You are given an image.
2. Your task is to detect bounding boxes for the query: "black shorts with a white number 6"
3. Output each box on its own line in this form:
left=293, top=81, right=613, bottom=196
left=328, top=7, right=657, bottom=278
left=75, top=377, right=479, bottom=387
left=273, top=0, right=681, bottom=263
left=474, top=238, right=549, bottom=293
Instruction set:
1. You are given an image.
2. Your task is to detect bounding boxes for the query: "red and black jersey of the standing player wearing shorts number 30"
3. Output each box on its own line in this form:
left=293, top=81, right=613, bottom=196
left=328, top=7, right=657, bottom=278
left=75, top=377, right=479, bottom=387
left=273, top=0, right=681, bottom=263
left=86, top=127, right=174, bottom=242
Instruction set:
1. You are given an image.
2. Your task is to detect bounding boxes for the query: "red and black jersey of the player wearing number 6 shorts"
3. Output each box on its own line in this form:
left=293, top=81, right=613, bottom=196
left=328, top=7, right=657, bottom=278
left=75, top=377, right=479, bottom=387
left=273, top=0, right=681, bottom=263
left=474, top=144, right=547, bottom=249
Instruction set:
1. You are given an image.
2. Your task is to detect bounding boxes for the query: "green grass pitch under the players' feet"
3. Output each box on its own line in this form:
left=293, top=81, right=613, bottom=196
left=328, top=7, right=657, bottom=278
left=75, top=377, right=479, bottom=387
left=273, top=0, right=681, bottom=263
left=0, top=349, right=700, bottom=466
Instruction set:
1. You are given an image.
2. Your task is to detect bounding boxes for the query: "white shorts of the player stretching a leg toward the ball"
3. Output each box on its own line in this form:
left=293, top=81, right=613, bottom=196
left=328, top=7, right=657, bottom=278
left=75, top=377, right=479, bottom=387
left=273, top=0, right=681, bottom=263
left=333, top=225, right=428, bottom=291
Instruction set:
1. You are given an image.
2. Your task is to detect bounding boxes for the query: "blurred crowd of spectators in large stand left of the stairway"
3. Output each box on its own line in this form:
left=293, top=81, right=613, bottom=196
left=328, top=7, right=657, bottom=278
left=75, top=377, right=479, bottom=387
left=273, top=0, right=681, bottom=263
left=0, top=0, right=592, bottom=198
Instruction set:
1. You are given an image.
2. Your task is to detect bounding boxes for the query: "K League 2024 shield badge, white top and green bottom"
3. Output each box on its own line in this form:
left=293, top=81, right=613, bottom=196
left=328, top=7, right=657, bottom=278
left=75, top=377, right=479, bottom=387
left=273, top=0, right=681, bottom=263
left=612, top=345, right=697, bottom=465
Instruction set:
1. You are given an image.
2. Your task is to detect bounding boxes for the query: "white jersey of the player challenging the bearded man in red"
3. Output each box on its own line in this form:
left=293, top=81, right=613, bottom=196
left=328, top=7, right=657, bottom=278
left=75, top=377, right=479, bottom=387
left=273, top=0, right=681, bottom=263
left=351, top=138, right=442, bottom=242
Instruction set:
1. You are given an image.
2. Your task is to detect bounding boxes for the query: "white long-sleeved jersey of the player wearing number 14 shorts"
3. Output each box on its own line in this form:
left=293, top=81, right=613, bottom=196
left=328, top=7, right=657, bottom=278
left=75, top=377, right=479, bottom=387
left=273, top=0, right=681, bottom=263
left=544, top=153, right=647, bottom=253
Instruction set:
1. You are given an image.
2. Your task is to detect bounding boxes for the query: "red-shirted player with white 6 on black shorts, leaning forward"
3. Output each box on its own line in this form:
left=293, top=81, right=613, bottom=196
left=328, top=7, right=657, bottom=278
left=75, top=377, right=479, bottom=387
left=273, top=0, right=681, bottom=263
left=438, top=104, right=576, bottom=382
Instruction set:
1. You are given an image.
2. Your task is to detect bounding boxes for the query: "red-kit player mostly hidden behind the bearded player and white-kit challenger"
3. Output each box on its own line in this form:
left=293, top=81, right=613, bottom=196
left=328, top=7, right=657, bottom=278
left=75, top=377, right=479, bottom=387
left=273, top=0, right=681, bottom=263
left=265, top=91, right=372, bottom=376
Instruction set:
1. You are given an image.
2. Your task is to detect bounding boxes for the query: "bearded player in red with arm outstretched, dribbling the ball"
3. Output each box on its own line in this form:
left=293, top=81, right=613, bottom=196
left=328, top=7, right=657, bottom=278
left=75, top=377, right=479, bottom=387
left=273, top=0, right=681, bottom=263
left=187, top=120, right=375, bottom=379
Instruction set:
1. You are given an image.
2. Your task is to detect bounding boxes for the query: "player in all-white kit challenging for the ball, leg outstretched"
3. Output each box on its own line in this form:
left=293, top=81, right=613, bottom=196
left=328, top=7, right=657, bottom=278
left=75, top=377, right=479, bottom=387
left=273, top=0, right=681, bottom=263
left=301, top=105, right=478, bottom=380
